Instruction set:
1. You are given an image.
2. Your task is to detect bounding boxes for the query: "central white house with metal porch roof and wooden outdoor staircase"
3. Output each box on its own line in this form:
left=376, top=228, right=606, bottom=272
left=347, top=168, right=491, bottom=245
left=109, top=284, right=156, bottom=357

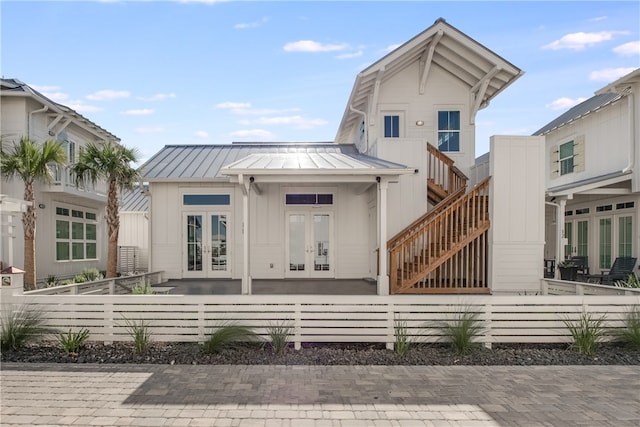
left=142, top=19, right=544, bottom=294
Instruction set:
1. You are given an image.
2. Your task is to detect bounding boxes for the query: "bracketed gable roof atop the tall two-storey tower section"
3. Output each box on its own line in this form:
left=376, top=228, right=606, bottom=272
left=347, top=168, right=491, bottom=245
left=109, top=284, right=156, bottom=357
left=336, top=18, right=523, bottom=142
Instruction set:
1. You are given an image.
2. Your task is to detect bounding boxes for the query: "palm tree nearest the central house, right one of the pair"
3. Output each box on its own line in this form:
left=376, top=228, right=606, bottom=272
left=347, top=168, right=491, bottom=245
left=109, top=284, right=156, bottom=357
left=71, top=141, right=140, bottom=277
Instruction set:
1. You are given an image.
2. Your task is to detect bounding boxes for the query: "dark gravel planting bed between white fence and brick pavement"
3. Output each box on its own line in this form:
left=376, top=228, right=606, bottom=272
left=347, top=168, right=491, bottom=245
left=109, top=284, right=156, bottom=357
left=1, top=342, right=640, bottom=365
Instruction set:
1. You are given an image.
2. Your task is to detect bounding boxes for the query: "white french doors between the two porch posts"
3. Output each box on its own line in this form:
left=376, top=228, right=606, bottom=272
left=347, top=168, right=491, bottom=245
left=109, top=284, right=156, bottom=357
left=286, top=212, right=334, bottom=277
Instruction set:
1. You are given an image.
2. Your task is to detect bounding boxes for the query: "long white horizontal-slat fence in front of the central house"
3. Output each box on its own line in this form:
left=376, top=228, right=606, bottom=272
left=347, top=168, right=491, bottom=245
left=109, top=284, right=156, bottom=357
left=2, top=295, right=640, bottom=348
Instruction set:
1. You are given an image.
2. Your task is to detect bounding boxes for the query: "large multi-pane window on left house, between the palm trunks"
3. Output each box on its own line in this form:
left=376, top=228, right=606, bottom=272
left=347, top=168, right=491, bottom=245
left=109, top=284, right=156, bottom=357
left=56, top=207, right=98, bottom=261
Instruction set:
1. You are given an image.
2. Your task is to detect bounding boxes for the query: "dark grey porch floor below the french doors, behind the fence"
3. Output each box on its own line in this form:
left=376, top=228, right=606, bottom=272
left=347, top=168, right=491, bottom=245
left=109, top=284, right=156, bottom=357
left=158, top=279, right=377, bottom=295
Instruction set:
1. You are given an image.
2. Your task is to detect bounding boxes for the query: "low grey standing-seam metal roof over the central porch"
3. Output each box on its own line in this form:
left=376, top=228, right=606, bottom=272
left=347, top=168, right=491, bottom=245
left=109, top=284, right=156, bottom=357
left=141, top=143, right=408, bottom=181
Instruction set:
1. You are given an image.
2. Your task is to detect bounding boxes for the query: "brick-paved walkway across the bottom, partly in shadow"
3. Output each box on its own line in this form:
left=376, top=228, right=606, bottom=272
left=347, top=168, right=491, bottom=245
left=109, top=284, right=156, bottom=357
left=0, top=363, right=640, bottom=427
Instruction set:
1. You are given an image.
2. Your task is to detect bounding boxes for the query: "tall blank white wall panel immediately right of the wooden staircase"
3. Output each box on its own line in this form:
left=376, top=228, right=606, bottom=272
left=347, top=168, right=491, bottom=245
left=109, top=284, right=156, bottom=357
left=489, top=136, right=545, bottom=294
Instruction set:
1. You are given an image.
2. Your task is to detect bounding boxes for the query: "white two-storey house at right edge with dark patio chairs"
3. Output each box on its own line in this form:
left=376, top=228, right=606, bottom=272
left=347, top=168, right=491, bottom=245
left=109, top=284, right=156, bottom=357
left=535, top=69, right=640, bottom=274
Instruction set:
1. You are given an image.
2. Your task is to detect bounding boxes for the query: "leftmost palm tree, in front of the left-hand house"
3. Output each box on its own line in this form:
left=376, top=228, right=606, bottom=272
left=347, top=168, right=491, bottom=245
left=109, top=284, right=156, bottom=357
left=0, top=137, right=67, bottom=289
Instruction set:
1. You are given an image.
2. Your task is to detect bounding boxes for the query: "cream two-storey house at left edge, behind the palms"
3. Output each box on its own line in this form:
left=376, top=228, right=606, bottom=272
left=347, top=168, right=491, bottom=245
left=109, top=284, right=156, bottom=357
left=0, top=79, right=119, bottom=280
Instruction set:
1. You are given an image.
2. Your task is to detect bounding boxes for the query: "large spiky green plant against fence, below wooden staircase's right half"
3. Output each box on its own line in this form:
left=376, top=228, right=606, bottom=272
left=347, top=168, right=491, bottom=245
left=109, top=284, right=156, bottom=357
left=442, top=307, right=484, bottom=355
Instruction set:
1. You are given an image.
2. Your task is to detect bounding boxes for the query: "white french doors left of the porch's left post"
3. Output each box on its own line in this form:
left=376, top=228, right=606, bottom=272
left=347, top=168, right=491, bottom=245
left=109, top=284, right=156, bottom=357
left=183, top=212, right=231, bottom=277
